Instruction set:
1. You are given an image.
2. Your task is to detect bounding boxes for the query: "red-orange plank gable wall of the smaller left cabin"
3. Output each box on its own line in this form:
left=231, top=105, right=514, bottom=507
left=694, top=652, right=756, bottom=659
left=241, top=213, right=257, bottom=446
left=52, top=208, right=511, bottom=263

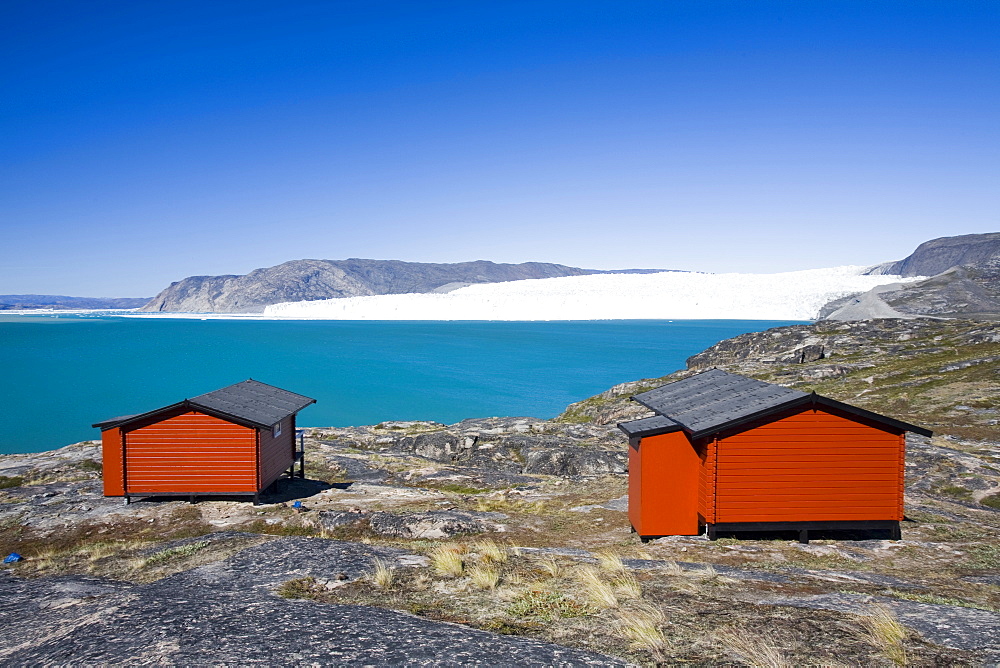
left=125, top=411, right=259, bottom=494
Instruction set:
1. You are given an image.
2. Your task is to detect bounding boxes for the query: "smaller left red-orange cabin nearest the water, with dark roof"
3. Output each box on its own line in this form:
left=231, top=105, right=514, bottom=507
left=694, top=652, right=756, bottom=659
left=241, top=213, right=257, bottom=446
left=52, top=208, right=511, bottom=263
left=94, top=380, right=316, bottom=503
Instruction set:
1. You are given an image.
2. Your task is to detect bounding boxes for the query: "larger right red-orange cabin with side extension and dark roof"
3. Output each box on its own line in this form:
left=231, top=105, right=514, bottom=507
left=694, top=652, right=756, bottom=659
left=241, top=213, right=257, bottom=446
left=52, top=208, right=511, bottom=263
left=618, top=369, right=931, bottom=541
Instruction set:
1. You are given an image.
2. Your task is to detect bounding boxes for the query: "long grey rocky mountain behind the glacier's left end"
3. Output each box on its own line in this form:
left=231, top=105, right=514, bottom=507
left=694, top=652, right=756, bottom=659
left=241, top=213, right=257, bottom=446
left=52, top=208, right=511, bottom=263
left=140, top=258, right=662, bottom=313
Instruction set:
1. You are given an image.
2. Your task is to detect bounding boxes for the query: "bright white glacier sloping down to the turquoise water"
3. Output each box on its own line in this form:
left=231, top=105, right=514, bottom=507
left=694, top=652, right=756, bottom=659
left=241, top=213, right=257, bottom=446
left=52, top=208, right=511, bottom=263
left=264, top=266, right=919, bottom=320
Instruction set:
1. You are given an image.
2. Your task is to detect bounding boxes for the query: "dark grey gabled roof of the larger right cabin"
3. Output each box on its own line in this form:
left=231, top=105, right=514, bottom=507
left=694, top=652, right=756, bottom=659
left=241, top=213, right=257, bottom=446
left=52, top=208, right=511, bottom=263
left=618, top=369, right=931, bottom=438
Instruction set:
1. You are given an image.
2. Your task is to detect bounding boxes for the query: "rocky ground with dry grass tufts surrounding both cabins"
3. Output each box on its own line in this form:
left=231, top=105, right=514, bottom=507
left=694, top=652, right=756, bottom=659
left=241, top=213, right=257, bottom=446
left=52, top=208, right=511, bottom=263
left=0, top=321, right=1000, bottom=666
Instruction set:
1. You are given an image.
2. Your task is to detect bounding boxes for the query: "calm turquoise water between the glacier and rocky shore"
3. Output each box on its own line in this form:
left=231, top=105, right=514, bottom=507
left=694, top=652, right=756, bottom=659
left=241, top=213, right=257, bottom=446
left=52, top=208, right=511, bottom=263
left=0, top=315, right=793, bottom=453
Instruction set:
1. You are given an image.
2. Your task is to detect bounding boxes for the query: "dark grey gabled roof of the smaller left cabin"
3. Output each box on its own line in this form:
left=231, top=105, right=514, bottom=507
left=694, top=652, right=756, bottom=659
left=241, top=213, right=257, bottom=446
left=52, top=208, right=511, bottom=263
left=93, top=380, right=316, bottom=430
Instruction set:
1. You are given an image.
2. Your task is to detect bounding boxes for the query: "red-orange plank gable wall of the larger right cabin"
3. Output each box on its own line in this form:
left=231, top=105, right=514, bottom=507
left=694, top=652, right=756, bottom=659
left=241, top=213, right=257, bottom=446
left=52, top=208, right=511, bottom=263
left=716, top=409, right=904, bottom=522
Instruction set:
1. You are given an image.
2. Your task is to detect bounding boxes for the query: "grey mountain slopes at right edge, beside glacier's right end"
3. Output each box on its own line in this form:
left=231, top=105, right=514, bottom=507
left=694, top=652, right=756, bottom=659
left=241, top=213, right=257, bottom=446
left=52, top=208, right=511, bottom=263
left=820, top=232, right=1000, bottom=320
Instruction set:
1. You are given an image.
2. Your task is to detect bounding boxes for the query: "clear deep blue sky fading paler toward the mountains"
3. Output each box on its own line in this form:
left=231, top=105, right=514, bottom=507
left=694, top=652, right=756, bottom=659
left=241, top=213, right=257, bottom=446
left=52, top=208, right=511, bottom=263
left=0, top=0, right=1000, bottom=296
